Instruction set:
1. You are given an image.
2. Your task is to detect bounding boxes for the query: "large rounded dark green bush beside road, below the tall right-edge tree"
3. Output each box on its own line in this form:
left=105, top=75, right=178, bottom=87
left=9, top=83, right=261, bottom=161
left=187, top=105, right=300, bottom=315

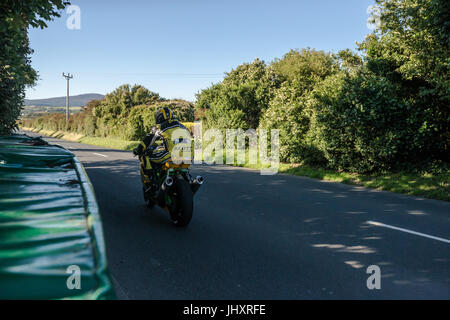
left=311, top=70, right=414, bottom=173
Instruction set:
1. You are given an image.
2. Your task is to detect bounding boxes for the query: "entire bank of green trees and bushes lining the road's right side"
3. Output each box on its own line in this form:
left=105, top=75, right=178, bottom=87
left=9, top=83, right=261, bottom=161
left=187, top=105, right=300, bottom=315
left=196, top=0, right=450, bottom=172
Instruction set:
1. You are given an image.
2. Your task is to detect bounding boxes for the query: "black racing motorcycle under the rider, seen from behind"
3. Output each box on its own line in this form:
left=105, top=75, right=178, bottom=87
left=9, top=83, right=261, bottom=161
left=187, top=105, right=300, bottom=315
left=144, top=144, right=204, bottom=227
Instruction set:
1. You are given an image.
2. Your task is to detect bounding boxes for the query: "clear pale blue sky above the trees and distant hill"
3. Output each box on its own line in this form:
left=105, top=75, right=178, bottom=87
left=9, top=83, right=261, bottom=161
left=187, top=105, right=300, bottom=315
left=26, top=0, right=374, bottom=101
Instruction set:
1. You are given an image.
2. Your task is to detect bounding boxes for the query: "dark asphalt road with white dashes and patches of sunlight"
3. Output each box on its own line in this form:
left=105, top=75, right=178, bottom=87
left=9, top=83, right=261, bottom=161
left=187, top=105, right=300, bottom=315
left=22, top=131, right=450, bottom=299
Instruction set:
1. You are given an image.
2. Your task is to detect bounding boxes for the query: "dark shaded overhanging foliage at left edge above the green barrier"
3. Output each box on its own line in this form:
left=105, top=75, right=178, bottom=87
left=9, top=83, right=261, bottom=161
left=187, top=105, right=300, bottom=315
left=0, top=0, right=68, bottom=134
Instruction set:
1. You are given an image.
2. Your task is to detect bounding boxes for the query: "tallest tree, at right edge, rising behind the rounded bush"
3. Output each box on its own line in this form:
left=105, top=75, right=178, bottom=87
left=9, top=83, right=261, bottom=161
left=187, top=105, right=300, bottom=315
left=359, top=0, right=450, bottom=160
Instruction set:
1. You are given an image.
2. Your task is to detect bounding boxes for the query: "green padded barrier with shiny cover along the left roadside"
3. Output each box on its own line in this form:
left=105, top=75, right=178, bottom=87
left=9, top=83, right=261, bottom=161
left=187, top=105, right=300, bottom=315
left=0, top=134, right=115, bottom=299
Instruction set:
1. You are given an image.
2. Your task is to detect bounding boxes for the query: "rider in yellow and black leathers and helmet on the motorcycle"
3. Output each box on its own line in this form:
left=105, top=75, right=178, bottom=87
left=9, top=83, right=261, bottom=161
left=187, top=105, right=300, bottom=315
left=133, top=107, right=190, bottom=189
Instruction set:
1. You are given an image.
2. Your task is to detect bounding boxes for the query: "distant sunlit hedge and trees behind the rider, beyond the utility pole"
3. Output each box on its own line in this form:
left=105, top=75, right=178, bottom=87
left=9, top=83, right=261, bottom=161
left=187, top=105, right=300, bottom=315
left=22, top=85, right=194, bottom=140
